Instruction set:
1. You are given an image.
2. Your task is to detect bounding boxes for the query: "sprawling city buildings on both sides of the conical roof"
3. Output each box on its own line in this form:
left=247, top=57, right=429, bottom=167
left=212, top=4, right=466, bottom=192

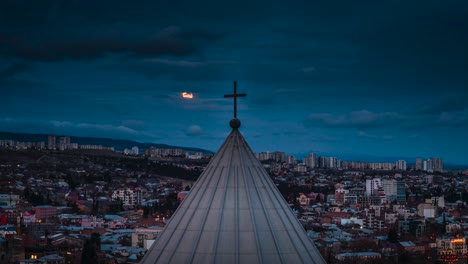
left=0, top=135, right=468, bottom=263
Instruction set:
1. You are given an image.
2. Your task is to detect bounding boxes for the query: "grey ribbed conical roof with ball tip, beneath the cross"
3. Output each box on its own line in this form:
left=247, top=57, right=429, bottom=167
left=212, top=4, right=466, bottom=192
left=141, top=119, right=325, bottom=264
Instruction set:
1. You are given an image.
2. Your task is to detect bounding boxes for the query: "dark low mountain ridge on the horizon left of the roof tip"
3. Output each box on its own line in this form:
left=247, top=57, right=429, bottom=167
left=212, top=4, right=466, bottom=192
left=0, top=132, right=213, bottom=154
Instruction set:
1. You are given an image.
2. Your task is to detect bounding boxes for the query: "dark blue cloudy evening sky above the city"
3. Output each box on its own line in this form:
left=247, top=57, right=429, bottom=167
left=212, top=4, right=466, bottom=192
left=0, top=0, right=468, bottom=164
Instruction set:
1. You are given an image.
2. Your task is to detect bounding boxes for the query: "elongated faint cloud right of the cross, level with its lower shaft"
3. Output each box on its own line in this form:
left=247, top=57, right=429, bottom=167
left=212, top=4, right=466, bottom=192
left=306, top=110, right=405, bottom=128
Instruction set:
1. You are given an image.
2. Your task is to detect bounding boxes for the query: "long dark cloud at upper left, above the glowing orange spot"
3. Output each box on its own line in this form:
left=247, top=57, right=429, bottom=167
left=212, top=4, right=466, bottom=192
left=0, top=26, right=225, bottom=62
